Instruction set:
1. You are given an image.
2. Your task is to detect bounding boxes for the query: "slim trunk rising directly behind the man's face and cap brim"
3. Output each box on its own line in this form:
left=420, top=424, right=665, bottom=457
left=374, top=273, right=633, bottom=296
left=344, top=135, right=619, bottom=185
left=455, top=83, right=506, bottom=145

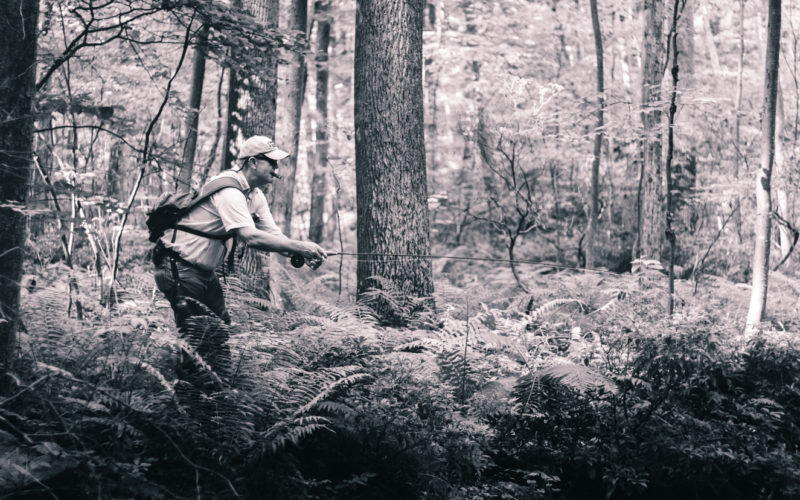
left=270, top=0, right=308, bottom=235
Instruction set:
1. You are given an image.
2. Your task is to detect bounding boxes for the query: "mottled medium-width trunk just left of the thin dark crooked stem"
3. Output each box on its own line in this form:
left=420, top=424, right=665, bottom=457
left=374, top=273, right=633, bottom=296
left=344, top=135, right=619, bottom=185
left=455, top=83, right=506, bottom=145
left=639, top=0, right=665, bottom=260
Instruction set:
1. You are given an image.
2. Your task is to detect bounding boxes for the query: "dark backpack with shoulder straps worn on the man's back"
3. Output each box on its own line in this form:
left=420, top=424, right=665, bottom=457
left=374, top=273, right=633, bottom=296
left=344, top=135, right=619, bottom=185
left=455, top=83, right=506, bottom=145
left=147, top=176, right=244, bottom=243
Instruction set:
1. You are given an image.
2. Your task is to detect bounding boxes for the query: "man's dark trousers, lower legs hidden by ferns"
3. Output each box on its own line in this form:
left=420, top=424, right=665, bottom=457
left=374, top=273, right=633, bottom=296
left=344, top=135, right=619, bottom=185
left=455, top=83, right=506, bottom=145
left=155, top=257, right=231, bottom=382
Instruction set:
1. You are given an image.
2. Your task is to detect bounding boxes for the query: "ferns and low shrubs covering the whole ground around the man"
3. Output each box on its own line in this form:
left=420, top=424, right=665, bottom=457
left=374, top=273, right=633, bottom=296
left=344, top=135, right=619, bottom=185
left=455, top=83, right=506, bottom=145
left=0, top=232, right=800, bottom=499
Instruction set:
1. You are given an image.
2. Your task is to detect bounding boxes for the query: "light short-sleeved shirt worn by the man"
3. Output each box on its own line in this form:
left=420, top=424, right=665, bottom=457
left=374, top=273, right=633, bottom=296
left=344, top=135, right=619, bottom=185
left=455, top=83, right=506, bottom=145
left=161, top=170, right=283, bottom=271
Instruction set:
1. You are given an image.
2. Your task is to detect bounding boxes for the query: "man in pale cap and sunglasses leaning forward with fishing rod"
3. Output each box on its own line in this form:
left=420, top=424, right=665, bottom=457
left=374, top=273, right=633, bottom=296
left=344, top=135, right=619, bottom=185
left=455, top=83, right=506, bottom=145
left=154, top=136, right=327, bottom=378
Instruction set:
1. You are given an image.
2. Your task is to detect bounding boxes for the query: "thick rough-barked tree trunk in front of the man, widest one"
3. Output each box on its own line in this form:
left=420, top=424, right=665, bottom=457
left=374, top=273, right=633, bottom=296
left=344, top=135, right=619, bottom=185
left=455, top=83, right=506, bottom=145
left=355, top=0, right=433, bottom=322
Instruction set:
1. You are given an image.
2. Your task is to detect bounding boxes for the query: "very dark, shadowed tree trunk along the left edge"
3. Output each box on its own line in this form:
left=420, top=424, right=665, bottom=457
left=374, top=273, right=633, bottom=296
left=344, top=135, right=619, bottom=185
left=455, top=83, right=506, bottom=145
left=0, top=0, right=39, bottom=394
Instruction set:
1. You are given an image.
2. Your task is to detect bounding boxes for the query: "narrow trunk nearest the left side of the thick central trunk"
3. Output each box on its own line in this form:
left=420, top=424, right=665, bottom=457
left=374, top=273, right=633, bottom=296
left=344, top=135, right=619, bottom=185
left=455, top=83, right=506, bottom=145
left=308, top=0, right=331, bottom=243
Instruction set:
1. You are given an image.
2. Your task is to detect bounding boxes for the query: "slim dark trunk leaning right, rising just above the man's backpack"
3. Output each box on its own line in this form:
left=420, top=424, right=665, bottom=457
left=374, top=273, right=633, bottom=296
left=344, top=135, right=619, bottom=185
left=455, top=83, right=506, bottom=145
left=176, top=24, right=208, bottom=192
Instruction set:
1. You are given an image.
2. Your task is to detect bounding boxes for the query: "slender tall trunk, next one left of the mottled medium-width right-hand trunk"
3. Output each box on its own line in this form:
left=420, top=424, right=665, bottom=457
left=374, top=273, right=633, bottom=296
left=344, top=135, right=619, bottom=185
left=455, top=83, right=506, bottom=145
left=586, top=0, right=605, bottom=269
